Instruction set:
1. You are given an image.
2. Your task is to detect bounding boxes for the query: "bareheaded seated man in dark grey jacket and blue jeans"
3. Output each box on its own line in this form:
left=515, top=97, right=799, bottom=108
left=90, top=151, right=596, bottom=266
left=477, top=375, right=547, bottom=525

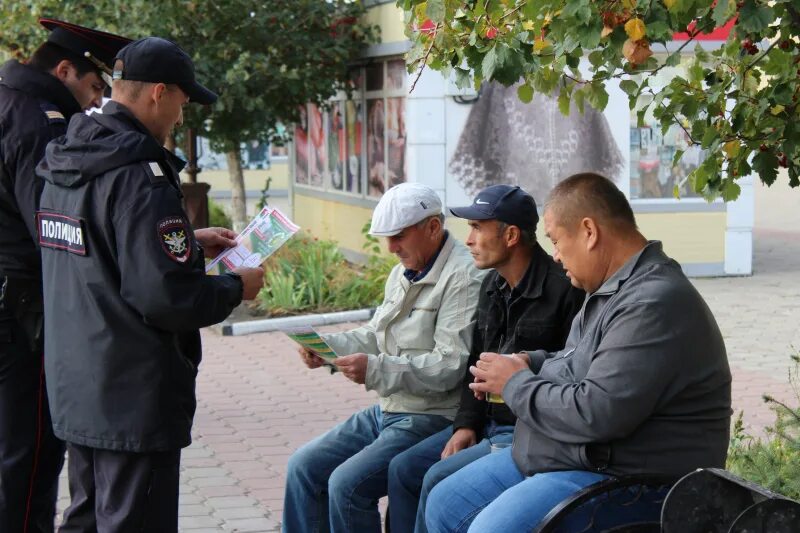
left=425, top=173, right=731, bottom=532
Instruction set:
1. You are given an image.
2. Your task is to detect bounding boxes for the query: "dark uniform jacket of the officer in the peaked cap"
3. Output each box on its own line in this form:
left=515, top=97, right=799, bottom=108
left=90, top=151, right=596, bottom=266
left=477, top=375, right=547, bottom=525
left=0, top=60, right=81, bottom=280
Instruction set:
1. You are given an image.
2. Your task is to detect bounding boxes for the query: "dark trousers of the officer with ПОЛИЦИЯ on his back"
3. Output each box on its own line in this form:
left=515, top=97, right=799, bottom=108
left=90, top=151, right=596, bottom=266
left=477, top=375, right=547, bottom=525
left=59, top=443, right=181, bottom=533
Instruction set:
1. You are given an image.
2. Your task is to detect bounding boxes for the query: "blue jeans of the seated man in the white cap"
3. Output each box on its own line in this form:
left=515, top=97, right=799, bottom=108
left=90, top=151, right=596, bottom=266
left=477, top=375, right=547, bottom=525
left=282, top=405, right=452, bottom=533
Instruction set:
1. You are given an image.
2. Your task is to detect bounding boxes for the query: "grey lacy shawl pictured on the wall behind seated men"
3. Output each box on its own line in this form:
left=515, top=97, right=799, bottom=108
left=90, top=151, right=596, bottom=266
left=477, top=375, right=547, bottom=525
left=448, top=83, right=626, bottom=204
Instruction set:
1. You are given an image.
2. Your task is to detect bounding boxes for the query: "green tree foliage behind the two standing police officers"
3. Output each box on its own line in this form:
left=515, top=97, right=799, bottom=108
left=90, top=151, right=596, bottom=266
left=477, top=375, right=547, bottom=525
left=0, top=0, right=374, bottom=151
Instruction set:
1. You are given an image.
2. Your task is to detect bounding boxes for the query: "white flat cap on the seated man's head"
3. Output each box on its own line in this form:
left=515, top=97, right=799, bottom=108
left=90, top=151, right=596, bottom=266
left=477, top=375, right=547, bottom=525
left=369, top=183, right=442, bottom=237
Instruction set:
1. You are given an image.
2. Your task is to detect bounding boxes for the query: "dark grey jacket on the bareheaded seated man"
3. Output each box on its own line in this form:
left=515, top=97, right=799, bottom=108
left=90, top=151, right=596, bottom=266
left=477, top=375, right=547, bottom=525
left=503, top=242, right=731, bottom=476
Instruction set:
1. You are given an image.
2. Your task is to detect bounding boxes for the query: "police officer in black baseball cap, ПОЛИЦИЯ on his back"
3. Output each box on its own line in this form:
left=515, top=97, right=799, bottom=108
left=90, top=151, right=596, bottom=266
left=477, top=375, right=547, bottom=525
left=36, top=37, right=264, bottom=533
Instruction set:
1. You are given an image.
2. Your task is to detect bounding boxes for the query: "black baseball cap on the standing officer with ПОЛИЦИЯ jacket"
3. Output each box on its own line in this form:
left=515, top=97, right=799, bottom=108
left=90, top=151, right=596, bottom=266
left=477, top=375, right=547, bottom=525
left=111, top=37, right=217, bottom=105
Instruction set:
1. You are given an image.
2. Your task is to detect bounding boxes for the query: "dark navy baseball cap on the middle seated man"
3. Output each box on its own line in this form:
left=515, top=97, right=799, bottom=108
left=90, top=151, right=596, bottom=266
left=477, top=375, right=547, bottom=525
left=450, top=185, right=539, bottom=230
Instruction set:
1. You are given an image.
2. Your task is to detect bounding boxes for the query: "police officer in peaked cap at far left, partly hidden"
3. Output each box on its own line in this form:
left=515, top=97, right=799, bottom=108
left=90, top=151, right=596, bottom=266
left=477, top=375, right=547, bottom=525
left=0, top=19, right=130, bottom=533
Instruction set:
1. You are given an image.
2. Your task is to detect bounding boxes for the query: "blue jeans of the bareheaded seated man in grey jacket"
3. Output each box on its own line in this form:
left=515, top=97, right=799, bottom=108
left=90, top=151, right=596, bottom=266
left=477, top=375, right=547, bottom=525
left=425, top=448, right=608, bottom=533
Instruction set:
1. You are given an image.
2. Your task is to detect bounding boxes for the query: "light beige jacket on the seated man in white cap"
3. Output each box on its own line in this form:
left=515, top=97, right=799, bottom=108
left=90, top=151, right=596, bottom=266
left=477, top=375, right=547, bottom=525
left=325, top=236, right=484, bottom=418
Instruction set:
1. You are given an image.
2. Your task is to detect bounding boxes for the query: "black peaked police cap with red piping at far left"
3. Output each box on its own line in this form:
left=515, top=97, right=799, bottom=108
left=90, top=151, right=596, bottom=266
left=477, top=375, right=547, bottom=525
left=39, top=18, right=131, bottom=83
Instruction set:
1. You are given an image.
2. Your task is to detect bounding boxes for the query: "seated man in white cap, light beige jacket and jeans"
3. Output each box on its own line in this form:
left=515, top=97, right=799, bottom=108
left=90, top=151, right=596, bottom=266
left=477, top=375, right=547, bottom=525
left=283, top=183, right=482, bottom=533
